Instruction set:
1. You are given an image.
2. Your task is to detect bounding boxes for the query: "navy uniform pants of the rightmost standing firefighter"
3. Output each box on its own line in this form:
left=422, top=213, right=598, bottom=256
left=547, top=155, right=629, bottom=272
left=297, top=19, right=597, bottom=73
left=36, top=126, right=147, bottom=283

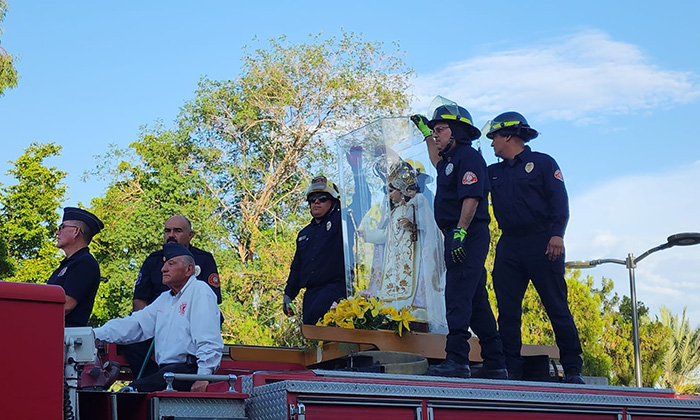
left=493, top=232, right=583, bottom=378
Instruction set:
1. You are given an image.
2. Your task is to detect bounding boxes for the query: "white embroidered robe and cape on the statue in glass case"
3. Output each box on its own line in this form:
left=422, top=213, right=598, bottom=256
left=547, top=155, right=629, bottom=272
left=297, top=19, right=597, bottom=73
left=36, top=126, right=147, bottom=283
left=365, top=193, right=447, bottom=333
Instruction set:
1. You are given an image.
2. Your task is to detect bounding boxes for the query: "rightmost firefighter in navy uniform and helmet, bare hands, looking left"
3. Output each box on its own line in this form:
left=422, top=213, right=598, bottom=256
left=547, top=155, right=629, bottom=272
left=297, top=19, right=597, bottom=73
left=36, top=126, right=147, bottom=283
left=486, top=112, right=584, bottom=383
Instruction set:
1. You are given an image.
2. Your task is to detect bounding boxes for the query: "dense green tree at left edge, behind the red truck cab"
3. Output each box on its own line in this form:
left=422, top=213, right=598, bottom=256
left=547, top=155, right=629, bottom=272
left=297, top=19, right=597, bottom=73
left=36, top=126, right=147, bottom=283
left=0, top=143, right=66, bottom=283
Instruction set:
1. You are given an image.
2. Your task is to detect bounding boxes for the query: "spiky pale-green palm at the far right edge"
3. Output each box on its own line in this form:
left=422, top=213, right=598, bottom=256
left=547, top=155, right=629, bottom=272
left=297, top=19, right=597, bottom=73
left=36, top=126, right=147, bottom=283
left=659, top=307, right=700, bottom=394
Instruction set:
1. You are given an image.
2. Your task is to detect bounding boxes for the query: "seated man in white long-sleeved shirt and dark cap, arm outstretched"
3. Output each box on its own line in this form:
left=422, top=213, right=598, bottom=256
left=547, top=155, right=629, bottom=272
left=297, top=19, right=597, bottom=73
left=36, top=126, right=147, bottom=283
left=95, top=243, right=224, bottom=392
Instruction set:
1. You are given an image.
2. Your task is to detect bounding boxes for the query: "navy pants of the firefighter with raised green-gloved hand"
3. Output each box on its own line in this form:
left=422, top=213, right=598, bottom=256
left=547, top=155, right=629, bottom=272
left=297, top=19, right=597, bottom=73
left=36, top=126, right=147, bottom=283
left=445, top=222, right=505, bottom=369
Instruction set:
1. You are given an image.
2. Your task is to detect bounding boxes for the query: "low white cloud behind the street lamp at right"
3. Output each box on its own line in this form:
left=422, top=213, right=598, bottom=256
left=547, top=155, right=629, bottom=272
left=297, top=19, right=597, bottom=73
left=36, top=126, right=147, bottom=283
left=566, top=161, right=700, bottom=324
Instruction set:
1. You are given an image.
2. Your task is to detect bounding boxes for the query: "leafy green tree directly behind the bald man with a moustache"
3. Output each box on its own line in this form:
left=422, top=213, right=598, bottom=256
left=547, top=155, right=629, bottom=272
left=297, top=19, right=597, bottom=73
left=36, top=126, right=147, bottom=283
left=86, top=125, right=226, bottom=325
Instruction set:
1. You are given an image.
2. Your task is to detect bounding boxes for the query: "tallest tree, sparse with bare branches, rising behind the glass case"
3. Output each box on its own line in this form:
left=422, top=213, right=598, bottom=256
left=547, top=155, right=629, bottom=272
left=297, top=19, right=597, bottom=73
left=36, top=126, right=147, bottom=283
left=181, top=33, right=410, bottom=264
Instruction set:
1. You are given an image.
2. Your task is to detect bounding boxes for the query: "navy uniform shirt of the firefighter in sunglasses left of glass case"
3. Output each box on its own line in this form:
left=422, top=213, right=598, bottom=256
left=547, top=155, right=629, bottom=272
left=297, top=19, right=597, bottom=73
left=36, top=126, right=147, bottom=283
left=284, top=207, right=345, bottom=299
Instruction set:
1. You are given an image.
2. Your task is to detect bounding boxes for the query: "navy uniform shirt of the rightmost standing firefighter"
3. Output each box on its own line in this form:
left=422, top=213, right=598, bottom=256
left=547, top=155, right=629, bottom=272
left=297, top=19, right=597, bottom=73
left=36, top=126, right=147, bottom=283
left=488, top=146, right=569, bottom=237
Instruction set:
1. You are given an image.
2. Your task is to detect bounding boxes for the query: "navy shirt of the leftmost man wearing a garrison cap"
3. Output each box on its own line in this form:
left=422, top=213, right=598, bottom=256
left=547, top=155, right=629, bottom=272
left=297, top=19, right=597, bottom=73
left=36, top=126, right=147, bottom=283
left=48, top=247, right=100, bottom=327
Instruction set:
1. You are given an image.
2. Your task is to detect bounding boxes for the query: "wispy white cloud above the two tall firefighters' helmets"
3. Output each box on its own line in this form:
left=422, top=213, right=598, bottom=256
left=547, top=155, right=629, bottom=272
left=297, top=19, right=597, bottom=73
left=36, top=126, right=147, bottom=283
left=414, top=31, right=700, bottom=123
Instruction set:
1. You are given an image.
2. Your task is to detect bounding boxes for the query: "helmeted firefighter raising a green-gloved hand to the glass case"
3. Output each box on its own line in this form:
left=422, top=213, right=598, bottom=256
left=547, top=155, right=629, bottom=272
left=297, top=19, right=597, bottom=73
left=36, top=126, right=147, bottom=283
left=411, top=105, right=508, bottom=379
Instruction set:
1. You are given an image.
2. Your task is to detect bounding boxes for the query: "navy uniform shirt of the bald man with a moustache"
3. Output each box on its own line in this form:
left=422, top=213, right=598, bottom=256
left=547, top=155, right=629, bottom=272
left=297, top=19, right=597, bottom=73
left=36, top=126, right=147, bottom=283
left=134, top=245, right=221, bottom=304
